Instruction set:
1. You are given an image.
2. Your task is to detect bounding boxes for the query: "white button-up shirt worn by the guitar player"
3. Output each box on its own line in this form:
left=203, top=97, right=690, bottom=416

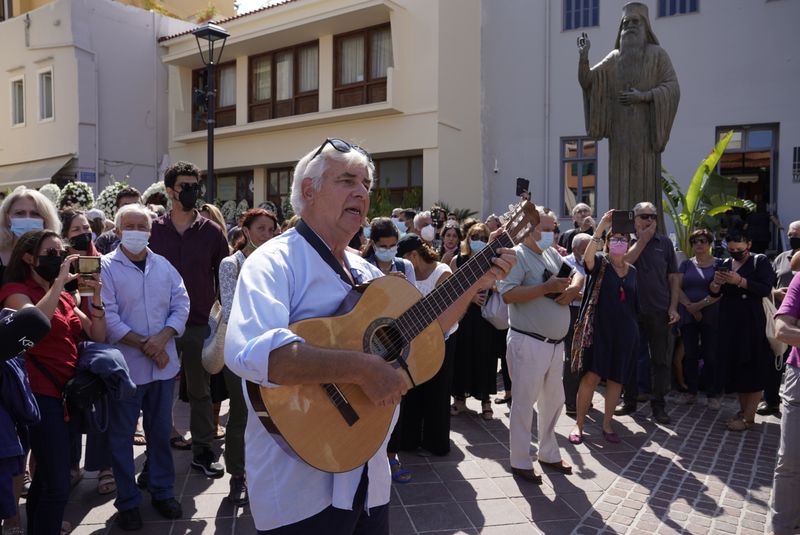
left=225, top=229, right=397, bottom=530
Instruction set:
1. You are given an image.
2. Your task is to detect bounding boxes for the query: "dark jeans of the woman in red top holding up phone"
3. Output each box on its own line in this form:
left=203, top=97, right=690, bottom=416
left=25, top=394, right=76, bottom=535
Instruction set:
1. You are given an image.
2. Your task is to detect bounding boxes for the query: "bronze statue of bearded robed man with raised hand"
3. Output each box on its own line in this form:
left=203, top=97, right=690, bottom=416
left=578, top=2, right=680, bottom=226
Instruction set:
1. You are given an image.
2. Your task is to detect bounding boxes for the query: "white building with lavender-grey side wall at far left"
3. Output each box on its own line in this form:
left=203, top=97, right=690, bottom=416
left=0, top=0, right=192, bottom=191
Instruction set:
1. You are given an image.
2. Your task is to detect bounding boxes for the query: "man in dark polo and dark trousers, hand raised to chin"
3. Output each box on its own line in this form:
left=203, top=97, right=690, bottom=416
left=616, top=202, right=681, bottom=425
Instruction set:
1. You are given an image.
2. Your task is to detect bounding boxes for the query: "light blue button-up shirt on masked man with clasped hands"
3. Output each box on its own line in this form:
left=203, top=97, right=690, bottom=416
left=100, top=247, right=189, bottom=385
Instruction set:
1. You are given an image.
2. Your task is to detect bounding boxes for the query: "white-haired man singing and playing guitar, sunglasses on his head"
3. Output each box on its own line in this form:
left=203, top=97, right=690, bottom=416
left=225, top=138, right=514, bottom=535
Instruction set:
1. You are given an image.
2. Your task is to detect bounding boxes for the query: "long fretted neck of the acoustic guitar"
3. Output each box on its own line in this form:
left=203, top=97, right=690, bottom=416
left=395, top=232, right=514, bottom=343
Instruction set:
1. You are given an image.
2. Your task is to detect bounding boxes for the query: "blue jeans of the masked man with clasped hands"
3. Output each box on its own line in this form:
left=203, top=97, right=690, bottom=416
left=108, top=379, right=175, bottom=511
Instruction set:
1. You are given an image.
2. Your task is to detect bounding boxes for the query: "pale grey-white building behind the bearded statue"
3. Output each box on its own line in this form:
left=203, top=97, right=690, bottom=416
left=481, top=0, right=800, bottom=253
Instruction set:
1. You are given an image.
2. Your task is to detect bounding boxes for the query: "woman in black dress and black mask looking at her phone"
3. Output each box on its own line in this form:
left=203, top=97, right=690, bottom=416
left=708, top=230, right=775, bottom=431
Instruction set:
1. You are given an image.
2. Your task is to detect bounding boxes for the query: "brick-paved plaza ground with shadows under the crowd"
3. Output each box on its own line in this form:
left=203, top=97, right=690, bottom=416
left=45, top=388, right=780, bottom=535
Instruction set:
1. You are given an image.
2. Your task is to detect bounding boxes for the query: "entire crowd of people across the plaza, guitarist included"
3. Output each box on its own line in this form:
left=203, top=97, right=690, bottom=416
left=0, top=139, right=800, bottom=535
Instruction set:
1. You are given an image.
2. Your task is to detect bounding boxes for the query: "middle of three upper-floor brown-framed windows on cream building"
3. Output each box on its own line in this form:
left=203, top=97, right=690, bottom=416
left=247, top=42, right=319, bottom=122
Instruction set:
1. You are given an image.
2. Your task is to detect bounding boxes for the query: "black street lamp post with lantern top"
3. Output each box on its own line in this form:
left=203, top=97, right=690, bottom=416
left=192, top=22, right=230, bottom=203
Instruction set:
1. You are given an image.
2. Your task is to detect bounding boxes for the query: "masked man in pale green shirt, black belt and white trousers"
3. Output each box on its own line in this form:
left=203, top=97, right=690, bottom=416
left=497, top=208, right=583, bottom=484
